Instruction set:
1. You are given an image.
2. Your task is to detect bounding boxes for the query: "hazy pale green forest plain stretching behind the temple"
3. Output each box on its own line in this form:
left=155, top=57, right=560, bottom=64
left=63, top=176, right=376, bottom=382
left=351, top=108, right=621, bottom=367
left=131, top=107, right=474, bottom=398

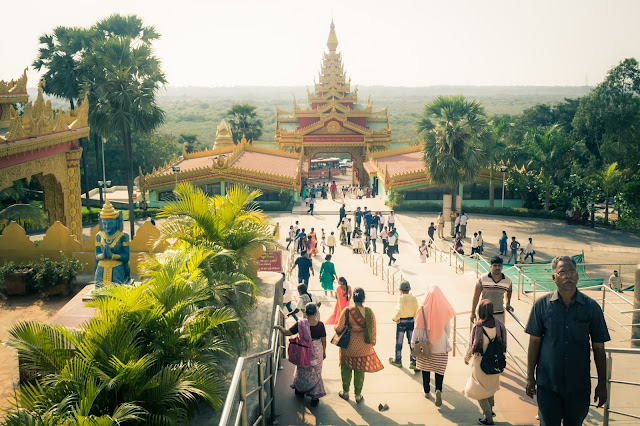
left=29, top=86, right=592, bottom=149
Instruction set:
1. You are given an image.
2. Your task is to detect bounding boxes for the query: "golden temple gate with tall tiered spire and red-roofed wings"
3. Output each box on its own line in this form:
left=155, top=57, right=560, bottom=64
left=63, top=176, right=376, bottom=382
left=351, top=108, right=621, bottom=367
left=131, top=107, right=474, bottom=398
left=140, top=21, right=504, bottom=207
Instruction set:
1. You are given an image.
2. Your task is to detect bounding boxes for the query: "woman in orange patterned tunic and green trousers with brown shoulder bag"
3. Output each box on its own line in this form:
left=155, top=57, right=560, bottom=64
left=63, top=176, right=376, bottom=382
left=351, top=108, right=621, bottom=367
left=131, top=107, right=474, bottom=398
left=335, top=288, right=384, bottom=403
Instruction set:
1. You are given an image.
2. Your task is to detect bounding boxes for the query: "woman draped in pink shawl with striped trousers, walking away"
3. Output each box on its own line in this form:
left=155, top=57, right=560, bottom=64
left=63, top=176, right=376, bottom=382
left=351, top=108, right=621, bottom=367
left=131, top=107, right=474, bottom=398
left=411, top=285, right=456, bottom=407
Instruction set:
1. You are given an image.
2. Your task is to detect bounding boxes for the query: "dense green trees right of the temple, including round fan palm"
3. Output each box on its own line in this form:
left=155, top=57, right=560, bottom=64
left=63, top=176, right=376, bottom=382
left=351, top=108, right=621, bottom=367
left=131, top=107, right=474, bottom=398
left=417, top=58, right=640, bottom=227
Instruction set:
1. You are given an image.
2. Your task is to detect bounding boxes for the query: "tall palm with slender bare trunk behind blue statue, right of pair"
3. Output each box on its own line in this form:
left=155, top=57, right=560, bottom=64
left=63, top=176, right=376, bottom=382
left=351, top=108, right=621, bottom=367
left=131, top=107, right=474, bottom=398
left=84, top=35, right=166, bottom=236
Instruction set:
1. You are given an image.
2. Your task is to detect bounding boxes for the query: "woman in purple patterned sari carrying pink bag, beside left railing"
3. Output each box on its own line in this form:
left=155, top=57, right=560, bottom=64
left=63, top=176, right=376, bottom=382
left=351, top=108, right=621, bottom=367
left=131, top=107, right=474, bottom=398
left=273, top=303, right=327, bottom=407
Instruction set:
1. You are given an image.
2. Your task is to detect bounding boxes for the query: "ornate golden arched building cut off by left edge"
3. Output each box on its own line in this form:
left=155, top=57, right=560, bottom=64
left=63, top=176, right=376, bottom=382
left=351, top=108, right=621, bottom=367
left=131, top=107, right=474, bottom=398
left=0, top=69, right=89, bottom=238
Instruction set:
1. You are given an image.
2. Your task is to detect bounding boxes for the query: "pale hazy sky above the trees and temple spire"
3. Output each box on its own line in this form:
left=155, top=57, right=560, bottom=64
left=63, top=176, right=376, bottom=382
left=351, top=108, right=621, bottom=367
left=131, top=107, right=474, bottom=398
left=0, top=0, right=640, bottom=86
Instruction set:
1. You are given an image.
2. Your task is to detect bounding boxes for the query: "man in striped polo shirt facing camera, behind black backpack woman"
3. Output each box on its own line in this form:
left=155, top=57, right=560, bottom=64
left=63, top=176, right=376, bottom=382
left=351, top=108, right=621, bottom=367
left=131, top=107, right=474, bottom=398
left=471, top=256, right=513, bottom=323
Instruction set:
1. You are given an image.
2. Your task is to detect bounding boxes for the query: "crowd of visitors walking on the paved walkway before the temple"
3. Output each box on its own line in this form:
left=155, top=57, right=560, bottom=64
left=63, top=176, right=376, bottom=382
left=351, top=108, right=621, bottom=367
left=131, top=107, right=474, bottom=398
left=277, top=194, right=621, bottom=425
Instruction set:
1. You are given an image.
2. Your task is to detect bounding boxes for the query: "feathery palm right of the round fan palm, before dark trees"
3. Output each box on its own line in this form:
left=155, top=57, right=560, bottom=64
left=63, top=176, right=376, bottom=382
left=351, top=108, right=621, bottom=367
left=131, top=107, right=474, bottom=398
left=525, top=124, right=571, bottom=211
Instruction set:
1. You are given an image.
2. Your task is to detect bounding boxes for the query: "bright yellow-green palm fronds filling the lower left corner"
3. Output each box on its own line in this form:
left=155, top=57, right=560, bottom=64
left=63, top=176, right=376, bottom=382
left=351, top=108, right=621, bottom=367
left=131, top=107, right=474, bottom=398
left=1, top=246, right=242, bottom=425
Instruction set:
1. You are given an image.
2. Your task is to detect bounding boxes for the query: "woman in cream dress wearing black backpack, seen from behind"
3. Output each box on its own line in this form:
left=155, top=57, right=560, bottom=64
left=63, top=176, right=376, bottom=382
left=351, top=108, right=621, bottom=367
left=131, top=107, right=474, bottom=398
left=462, top=299, right=507, bottom=425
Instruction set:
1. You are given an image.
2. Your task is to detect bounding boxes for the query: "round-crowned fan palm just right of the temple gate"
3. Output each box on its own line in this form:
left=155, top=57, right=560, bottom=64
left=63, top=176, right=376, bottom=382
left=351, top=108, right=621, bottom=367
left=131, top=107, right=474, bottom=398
left=417, top=96, right=486, bottom=210
